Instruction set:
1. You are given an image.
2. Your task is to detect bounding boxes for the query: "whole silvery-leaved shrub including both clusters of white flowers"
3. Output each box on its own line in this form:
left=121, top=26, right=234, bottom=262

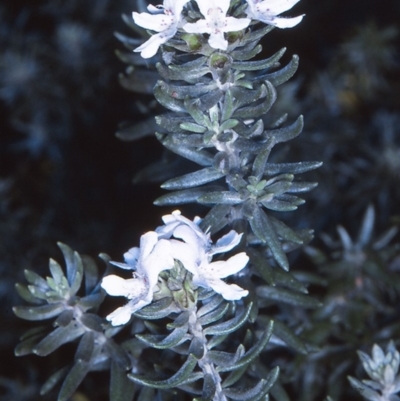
left=14, top=0, right=399, bottom=401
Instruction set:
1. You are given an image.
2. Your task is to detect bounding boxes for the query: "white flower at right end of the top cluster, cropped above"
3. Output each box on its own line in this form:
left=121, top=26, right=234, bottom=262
left=246, top=0, right=304, bottom=28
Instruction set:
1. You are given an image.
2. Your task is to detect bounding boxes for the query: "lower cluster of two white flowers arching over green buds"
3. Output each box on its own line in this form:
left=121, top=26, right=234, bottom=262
left=101, top=211, right=249, bottom=326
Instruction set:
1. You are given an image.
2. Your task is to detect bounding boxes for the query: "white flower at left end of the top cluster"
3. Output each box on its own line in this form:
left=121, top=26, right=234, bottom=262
left=132, top=0, right=189, bottom=58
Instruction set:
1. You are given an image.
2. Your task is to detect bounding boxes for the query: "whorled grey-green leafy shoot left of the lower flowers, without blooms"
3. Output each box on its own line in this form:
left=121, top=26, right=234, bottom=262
left=13, top=243, right=133, bottom=401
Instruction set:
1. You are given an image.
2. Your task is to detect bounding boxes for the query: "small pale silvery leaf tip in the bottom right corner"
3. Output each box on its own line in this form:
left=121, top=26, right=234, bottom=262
left=349, top=341, right=400, bottom=401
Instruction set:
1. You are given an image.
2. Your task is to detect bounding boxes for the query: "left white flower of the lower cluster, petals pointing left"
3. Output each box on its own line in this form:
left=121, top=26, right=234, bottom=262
left=101, top=231, right=174, bottom=326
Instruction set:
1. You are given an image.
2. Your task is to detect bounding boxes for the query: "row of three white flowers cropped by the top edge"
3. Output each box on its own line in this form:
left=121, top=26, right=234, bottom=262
left=132, top=0, right=303, bottom=58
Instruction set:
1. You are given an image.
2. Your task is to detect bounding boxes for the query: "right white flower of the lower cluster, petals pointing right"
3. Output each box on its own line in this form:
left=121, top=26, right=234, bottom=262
left=157, top=211, right=249, bottom=301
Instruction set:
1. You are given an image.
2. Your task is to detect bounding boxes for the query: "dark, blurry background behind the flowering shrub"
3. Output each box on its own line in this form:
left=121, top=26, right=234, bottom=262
left=0, top=0, right=400, bottom=400
